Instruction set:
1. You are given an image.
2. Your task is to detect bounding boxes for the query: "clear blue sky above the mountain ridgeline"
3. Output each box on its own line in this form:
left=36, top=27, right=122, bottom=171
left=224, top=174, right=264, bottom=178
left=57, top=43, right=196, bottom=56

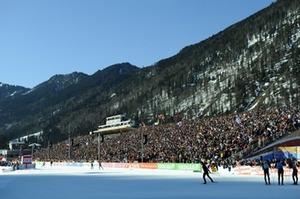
left=0, top=0, right=275, bottom=88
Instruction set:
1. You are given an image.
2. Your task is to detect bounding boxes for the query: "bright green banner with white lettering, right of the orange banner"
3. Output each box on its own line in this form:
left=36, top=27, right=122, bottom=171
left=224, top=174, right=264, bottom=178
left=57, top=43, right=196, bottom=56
left=157, top=163, right=201, bottom=171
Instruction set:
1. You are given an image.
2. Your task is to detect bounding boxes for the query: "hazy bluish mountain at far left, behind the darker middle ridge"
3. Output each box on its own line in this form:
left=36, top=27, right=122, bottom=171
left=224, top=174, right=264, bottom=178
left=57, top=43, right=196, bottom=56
left=0, top=72, right=87, bottom=132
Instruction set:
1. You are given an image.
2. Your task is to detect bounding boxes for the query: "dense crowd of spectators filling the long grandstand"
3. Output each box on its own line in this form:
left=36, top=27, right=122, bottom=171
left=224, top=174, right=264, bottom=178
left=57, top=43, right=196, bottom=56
left=35, top=106, right=300, bottom=165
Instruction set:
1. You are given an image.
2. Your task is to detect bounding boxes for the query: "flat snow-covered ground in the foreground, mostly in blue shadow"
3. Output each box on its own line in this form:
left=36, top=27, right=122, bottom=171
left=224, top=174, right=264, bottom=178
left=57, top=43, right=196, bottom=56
left=0, top=166, right=300, bottom=199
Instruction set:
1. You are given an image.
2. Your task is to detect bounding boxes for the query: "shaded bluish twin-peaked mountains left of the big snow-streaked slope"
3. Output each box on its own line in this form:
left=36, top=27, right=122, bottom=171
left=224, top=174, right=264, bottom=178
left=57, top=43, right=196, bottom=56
left=0, top=63, right=139, bottom=148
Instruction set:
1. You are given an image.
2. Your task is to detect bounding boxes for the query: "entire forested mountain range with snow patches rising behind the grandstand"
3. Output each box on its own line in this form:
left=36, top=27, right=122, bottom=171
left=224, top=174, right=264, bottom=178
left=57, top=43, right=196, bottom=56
left=0, top=0, right=300, bottom=148
